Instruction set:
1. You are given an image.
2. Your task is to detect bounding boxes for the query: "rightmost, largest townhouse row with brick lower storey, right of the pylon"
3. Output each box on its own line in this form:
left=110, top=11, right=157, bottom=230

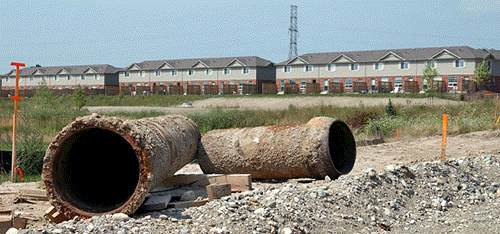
left=276, top=46, right=500, bottom=93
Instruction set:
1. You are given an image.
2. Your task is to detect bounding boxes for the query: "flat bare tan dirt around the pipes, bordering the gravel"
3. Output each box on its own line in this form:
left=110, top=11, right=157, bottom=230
left=0, top=130, right=500, bottom=229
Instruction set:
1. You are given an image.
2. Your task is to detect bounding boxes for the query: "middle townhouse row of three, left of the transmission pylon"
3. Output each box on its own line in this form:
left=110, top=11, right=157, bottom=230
left=119, top=56, right=276, bottom=94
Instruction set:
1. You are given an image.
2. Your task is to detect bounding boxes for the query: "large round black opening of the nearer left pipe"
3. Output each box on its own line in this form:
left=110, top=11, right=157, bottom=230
left=52, top=128, right=139, bottom=213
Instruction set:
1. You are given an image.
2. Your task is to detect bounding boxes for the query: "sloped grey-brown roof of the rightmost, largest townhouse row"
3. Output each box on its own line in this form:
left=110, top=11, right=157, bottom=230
left=277, top=46, right=500, bottom=65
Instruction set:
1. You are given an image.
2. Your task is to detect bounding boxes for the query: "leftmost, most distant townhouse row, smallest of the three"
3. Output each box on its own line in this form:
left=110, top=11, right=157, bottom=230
left=0, top=64, right=119, bottom=96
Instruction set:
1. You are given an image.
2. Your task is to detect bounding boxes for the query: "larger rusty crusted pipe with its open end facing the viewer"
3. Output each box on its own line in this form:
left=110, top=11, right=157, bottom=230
left=42, top=114, right=201, bottom=218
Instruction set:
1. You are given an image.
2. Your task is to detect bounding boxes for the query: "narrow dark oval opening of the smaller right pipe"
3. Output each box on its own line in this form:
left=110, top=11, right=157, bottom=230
left=328, top=121, right=356, bottom=174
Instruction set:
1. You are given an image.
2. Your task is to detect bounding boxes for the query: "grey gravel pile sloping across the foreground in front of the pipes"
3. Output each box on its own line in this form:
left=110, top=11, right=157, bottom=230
left=12, top=155, right=500, bottom=234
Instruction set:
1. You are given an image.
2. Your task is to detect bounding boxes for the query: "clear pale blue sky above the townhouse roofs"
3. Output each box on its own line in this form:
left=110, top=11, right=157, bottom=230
left=0, top=0, right=500, bottom=74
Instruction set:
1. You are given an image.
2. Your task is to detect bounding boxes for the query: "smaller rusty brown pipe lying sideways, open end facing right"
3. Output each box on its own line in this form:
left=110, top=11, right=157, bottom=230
left=198, top=117, right=356, bottom=179
